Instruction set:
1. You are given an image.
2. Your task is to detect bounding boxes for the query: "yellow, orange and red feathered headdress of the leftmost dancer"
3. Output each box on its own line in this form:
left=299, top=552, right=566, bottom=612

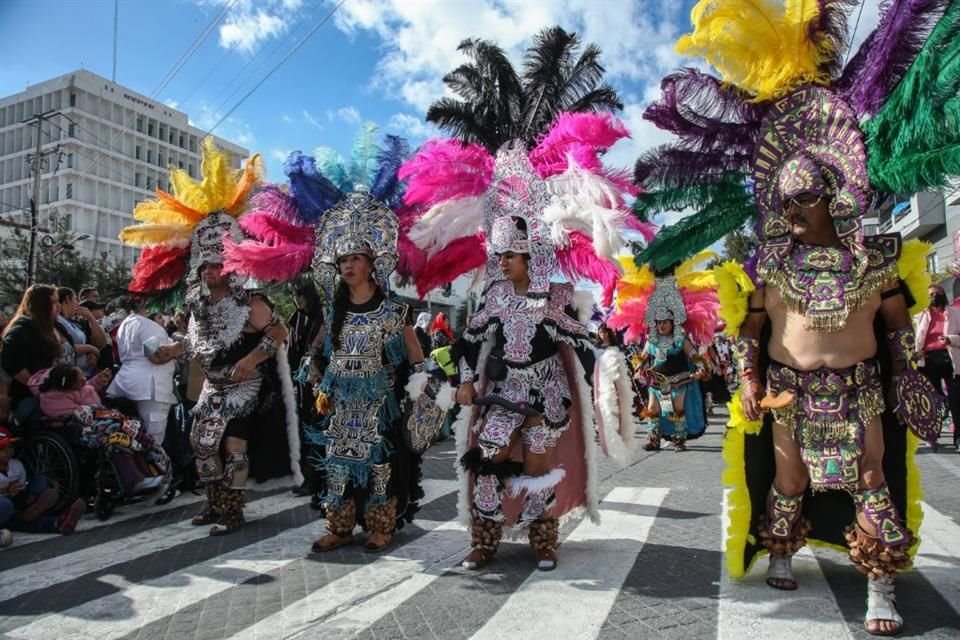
left=120, top=137, right=264, bottom=294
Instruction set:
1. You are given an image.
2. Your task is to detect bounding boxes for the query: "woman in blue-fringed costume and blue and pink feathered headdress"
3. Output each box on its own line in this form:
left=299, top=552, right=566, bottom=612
left=226, top=125, right=428, bottom=553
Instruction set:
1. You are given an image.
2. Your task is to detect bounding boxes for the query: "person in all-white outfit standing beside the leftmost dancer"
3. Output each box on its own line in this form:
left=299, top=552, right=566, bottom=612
left=107, top=300, right=177, bottom=444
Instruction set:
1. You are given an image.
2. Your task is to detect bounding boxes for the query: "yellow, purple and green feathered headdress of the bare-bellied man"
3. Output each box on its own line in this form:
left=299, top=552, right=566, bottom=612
left=634, top=0, right=960, bottom=269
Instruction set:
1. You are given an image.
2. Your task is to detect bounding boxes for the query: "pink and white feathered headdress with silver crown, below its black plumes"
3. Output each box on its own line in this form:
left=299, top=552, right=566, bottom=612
left=398, top=113, right=653, bottom=304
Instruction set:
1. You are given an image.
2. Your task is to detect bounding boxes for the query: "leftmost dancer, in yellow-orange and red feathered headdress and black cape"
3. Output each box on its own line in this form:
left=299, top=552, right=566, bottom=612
left=120, top=138, right=302, bottom=535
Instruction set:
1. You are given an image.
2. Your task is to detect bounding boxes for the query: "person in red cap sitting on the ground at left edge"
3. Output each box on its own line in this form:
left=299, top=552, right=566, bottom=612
left=0, top=427, right=86, bottom=546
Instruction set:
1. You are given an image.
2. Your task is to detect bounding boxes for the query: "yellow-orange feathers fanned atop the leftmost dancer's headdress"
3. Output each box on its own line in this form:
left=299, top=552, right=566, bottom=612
left=120, top=137, right=265, bottom=246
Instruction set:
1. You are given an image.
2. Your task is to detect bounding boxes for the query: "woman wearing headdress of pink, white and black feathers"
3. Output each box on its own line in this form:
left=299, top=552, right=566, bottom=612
left=401, top=28, right=650, bottom=571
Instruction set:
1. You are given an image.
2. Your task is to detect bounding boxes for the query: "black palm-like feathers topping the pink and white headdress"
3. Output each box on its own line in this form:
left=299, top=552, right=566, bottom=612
left=427, top=27, right=623, bottom=152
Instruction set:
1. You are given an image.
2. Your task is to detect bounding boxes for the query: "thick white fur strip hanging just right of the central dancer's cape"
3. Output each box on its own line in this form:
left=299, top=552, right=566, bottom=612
left=593, top=347, right=635, bottom=467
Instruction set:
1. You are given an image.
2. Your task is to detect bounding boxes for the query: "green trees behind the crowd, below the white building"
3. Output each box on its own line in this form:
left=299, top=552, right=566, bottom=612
left=0, top=228, right=130, bottom=307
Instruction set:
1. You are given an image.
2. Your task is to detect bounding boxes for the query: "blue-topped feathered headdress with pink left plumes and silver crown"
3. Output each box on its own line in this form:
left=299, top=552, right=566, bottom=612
left=225, top=124, right=409, bottom=299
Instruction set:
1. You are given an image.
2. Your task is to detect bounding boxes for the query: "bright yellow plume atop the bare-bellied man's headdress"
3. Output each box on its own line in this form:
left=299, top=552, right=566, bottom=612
left=676, top=0, right=836, bottom=102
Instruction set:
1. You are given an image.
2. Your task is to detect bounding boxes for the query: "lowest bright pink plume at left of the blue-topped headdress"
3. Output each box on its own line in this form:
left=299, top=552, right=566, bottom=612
left=223, top=238, right=313, bottom=282
